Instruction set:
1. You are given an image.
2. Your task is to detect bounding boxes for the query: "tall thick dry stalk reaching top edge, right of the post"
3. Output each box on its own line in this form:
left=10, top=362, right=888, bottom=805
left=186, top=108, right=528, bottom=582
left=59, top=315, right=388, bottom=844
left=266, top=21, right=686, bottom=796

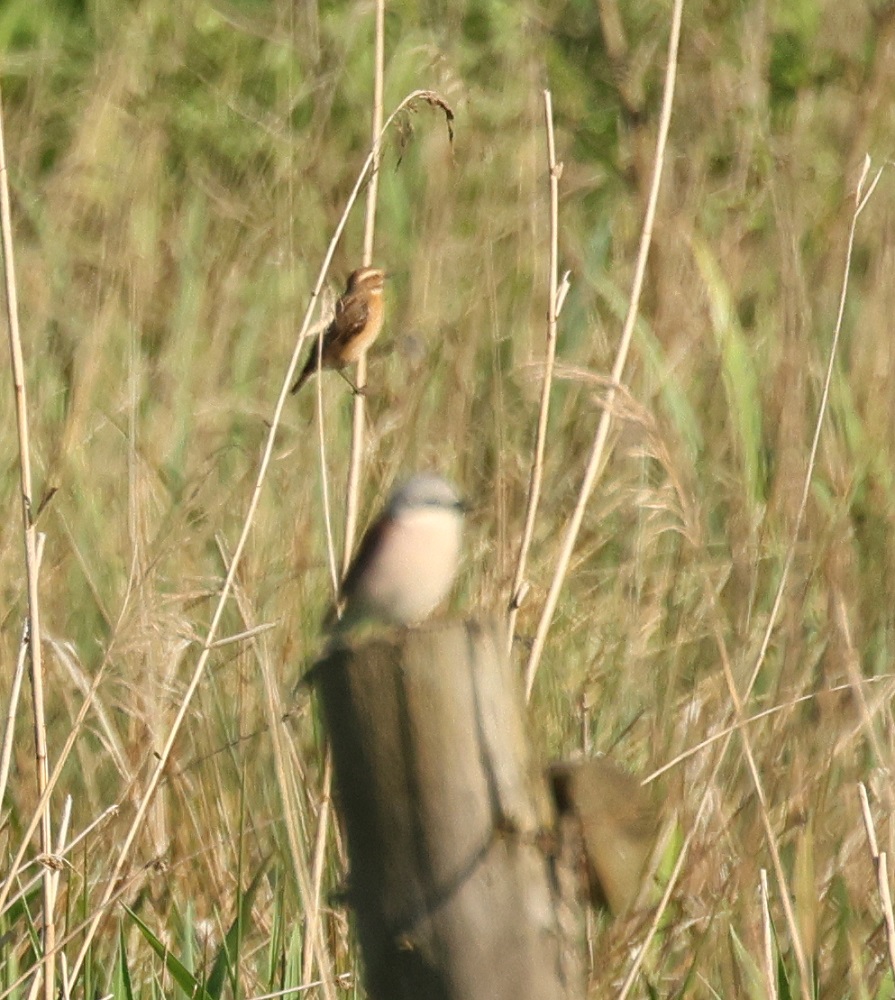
left=525, top=0, right=683, bottom=698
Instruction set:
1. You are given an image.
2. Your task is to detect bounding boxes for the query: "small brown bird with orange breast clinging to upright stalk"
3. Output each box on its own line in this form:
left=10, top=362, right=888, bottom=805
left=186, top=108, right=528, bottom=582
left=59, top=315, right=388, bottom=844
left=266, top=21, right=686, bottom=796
left=292, top=267, right=385, bottom=393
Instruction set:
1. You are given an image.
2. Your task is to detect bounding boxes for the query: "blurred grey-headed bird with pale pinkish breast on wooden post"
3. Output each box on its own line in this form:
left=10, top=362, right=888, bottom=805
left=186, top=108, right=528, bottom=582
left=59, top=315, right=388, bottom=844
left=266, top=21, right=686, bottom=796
left=328, top=472, right=465, bottom=633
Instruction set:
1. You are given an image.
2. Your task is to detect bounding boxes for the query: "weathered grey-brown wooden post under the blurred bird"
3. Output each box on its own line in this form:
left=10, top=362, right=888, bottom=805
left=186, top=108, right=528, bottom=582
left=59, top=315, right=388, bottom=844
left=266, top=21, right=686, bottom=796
left=313, top=622, right=584, bottom=1000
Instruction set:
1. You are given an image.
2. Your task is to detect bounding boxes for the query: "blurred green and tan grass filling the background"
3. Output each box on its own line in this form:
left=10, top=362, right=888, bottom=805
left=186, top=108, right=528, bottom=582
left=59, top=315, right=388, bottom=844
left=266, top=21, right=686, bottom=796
left=0, top=0, right=895, bottom=998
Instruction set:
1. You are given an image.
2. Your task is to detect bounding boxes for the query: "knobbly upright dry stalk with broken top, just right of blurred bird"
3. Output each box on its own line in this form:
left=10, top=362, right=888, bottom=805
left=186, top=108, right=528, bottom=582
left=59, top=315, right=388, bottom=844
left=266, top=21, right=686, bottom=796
left=507, top=90, right=569, bottom=651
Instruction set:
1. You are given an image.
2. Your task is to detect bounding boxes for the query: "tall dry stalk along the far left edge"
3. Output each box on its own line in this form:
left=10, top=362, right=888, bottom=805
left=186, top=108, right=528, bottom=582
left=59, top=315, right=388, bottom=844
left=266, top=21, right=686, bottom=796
left=0, top=84, right=56, bottom=1000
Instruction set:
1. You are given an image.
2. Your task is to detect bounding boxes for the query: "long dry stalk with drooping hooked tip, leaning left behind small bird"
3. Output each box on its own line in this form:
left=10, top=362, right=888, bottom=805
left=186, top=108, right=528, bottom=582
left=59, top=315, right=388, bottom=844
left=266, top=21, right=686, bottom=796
left=65, top=90, right=454, bottom=980
